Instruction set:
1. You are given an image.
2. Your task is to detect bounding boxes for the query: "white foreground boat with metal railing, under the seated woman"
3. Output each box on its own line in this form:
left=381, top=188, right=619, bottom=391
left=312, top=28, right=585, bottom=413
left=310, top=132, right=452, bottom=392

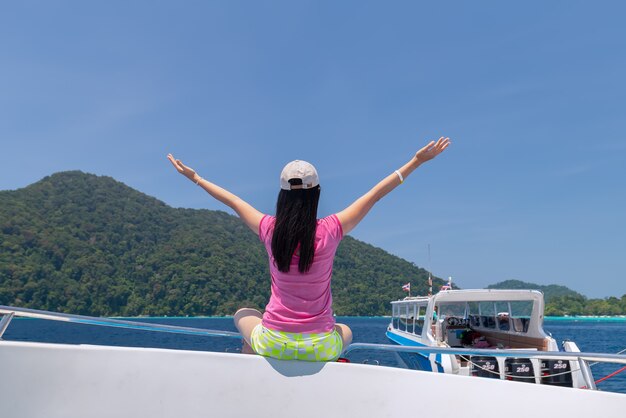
left=0, top=306, right=626, bottom=418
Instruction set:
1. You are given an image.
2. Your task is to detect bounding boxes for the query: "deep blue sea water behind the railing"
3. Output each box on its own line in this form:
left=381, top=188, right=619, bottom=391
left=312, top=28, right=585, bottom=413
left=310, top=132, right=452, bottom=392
left=3, top=317, right=626, bottom=393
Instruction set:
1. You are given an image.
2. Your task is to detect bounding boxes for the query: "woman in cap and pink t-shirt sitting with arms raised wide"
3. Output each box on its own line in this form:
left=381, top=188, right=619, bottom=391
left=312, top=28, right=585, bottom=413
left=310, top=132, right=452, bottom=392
left=168, top=137, right=450, bottom=361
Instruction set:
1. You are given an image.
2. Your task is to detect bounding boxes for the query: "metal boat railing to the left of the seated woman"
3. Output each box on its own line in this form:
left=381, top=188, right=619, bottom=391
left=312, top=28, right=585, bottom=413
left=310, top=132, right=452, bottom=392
left=0, top=305, right=241, bottom=339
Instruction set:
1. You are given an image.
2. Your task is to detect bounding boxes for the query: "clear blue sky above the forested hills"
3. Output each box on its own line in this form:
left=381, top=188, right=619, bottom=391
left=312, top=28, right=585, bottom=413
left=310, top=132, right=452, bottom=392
left=0, top=1, right=626, bottom=297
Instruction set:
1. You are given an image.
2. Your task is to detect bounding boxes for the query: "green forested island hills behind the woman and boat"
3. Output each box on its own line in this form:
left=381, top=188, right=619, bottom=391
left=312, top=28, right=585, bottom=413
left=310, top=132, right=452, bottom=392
left=0, top=171, right=626, bottom=316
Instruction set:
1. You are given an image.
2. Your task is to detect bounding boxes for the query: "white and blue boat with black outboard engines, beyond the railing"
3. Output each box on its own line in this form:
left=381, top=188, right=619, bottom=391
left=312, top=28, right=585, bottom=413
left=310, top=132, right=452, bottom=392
left=387, top=286, right=604, bottom=388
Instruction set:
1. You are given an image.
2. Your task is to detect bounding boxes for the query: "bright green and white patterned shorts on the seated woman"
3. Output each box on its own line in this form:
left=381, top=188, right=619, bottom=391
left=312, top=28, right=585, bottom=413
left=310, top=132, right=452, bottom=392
left=250, top=324, right=343, bottom=361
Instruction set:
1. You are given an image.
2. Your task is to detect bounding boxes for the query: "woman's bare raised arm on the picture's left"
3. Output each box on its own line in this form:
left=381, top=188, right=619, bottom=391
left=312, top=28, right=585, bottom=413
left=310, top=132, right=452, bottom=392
left=167, top=154, right=263, bottom=235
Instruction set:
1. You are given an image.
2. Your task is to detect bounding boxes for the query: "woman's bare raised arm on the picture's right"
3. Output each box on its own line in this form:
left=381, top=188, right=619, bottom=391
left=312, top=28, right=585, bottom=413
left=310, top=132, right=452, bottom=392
left=337, top=137, right=450, bottom=235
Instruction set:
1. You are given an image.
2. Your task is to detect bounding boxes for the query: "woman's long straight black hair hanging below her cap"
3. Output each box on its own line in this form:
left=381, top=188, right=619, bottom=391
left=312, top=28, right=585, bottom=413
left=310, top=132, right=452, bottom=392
left=272, top=179, right=320, bottom=273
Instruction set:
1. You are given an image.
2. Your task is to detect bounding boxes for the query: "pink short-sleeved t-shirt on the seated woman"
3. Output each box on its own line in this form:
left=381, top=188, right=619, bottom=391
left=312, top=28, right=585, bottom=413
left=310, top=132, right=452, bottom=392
left=259, top=215, right=343, bottom=333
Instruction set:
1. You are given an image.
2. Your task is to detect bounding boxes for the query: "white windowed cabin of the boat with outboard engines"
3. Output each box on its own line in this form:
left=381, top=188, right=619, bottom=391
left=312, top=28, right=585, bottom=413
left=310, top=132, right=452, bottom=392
left=389, top=289, right=558, bottom=351
